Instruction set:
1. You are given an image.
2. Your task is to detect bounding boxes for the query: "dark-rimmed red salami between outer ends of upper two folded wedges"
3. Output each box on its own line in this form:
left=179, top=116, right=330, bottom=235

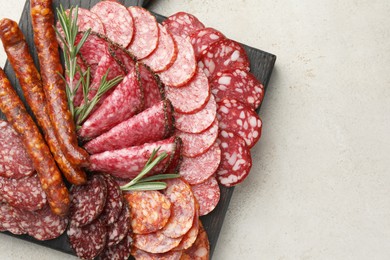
left=139, top=63, right=165, bottom=109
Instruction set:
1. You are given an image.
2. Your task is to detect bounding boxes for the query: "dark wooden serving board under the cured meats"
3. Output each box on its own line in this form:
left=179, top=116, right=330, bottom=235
left=0, top=0, right=276, bottom=255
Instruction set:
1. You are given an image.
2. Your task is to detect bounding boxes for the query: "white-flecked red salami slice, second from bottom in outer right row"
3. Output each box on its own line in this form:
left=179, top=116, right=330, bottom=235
left=217, top=99, right=262, bottom=148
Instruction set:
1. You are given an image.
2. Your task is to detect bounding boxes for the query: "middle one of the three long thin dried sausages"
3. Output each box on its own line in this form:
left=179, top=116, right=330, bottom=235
left=0, top=19, right=87, bottom=185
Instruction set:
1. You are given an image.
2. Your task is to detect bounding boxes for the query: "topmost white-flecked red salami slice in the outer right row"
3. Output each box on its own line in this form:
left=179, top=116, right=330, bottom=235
left=162, top=12, right=204, bottom=37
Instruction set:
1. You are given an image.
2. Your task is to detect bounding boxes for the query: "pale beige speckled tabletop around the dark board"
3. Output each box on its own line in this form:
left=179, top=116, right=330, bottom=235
left=0, top=0, right=390, bottom=260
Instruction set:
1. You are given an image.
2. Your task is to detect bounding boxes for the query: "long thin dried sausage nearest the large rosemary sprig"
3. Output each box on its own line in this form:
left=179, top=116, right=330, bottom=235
left=30, top=0, right=88, bottom=165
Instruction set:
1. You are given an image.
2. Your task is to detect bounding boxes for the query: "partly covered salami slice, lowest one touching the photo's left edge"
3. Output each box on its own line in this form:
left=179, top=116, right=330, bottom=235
left=0, top=202, right=26, bottom=235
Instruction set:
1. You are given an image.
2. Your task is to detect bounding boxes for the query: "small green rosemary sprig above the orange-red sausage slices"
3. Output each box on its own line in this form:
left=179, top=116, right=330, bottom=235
left=120, top=148, right=180, bottom=191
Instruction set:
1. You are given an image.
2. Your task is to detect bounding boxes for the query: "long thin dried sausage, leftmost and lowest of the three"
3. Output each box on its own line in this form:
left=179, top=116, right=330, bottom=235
left=0, top=69, right=70, bottom=216
